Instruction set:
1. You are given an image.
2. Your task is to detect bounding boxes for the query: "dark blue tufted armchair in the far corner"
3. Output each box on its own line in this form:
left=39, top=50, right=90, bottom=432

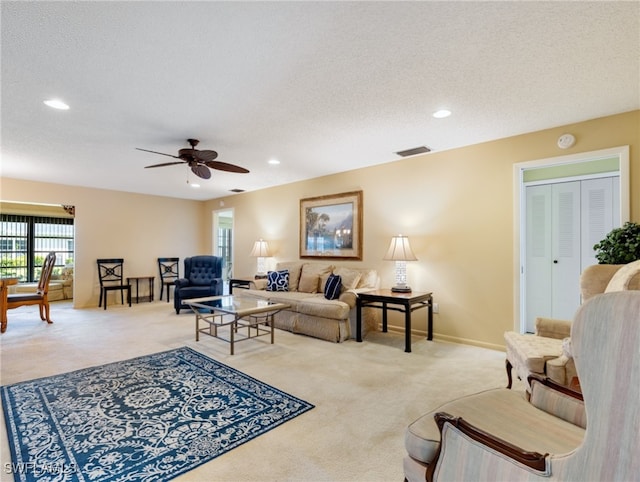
left=173, top=256, right=223, bottom=314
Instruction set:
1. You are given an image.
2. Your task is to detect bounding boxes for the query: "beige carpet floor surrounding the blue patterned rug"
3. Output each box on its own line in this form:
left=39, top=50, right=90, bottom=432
left=0, top=301, right=520, bottom=482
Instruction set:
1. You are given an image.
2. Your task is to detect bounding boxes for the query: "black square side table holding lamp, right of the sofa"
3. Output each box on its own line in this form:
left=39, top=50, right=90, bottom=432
left=356, top=290, right=433, bottom=353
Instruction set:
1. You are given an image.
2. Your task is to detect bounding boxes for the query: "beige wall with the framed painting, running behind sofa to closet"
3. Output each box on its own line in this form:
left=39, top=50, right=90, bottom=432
left=205, top=111, right=640, bottom=348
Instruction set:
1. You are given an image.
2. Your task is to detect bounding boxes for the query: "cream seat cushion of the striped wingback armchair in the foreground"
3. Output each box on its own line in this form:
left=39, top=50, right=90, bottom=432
left=405, top=388, right=585, bottom=464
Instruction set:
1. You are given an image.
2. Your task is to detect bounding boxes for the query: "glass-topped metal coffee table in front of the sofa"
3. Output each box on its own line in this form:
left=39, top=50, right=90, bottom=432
left=184, top=295, right=289, bottom=355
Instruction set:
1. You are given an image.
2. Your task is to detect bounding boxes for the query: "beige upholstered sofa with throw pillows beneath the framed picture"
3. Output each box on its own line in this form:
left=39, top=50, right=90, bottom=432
left=240, top=261, right=380, bottom=343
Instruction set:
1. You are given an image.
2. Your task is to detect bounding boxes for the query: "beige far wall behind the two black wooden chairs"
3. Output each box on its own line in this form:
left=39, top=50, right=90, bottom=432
left=0, top=178, right=205, bottom=308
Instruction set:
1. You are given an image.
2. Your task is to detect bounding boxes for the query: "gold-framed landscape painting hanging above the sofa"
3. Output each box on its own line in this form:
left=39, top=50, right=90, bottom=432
left=300, top=191, right=362, bottom=260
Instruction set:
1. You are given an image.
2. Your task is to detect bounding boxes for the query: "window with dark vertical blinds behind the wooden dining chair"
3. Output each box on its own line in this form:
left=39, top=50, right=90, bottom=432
left=0, top=214, right=74, bottom=282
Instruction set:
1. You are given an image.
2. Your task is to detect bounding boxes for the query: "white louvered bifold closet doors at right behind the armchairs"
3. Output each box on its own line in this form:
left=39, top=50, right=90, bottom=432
left=524, top=176, right=620, bottom=332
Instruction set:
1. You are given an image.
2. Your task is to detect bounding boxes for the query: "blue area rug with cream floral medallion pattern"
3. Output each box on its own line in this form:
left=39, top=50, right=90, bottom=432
left=2, top=347, right=313, bottom=482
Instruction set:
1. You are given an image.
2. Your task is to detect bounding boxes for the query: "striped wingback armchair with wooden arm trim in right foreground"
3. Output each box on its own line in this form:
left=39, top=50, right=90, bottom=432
left=405, top=291, right=640, bottom=482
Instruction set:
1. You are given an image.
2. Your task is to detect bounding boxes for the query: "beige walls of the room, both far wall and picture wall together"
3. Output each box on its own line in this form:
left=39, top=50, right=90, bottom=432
left=0, top=111, right=640, bottom=348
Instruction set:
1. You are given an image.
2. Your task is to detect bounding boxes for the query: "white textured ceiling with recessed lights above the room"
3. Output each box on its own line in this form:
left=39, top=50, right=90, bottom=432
left=0, top=1, right=640, bottom=199
